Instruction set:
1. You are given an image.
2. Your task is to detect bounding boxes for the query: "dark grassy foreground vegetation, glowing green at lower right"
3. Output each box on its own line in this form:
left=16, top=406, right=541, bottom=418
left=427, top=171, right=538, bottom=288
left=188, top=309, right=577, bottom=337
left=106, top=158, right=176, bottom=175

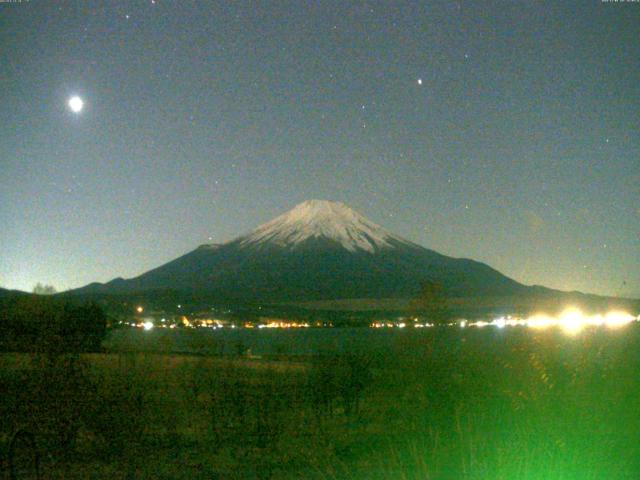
left=0, top=325, right=640, bottom=479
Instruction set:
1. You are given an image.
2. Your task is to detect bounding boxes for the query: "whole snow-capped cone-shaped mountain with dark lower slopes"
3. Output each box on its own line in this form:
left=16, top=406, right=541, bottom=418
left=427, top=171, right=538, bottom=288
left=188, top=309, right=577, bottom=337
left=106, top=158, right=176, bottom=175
left=69, top=200, right=541, bottom=302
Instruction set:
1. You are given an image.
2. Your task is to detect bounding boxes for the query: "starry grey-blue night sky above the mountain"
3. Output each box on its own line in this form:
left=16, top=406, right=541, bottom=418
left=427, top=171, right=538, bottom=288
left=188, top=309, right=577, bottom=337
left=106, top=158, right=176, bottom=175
left=0, top=0, right=640, bottom=297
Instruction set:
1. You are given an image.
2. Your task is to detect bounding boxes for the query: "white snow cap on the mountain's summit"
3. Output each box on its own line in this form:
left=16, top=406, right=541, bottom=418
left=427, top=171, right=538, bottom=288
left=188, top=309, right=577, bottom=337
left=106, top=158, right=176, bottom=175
left=240, top=200, right=410, bottom=253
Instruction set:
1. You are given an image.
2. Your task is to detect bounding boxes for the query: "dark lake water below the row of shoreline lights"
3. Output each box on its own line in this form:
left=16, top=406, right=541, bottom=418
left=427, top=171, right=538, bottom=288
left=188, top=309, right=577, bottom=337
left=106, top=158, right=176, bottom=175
left=104, top=325, right=640, bottom=355
